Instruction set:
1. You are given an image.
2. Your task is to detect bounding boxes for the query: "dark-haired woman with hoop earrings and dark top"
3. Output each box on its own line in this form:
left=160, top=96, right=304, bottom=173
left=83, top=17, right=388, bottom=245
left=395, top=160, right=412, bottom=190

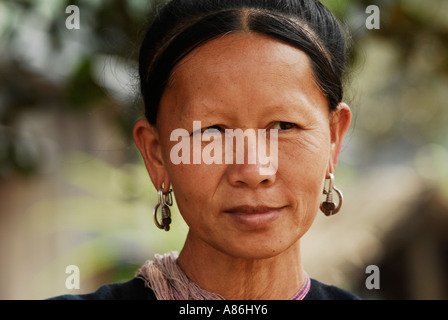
left=51, top=0, right=357, bottom=300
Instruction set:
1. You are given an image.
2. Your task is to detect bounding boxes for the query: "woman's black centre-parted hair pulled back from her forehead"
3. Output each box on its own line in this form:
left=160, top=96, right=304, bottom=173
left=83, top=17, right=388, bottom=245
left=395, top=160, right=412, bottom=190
left=139, top=0, right=346, bottom=125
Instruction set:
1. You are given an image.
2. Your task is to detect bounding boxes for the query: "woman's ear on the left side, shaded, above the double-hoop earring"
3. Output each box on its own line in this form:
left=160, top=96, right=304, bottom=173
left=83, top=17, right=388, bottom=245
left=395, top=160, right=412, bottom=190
left=133, top=119, right=170, bottom=192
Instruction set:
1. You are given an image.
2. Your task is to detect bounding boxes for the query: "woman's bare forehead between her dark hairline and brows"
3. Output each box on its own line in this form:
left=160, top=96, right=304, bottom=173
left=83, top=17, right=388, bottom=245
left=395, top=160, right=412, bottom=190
left=162, top=32, right=325, bottom=117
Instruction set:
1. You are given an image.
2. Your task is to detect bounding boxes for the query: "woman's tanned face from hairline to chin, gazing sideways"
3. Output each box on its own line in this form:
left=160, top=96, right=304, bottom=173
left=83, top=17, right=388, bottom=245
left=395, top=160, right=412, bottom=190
left=136, top=33, right=348, bottom=258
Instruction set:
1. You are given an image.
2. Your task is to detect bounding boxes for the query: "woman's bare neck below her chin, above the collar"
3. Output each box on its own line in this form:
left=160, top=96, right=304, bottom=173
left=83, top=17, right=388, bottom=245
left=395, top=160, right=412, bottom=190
left=178, top=234, right=306, bottom=300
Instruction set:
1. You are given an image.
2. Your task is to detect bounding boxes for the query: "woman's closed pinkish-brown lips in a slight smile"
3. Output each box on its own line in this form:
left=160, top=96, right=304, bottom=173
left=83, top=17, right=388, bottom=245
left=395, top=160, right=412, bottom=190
left=224, top=205, right=284, bottom=228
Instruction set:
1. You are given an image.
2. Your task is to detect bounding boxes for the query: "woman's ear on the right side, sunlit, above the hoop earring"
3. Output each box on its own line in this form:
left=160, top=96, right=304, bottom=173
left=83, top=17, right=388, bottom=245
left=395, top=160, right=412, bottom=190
left=326, top=102, right=352, bottom=178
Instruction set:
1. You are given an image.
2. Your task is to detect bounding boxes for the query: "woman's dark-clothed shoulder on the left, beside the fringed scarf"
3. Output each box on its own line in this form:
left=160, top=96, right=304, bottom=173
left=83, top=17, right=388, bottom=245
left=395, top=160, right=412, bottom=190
left=48, top=277, right=156, bottom=300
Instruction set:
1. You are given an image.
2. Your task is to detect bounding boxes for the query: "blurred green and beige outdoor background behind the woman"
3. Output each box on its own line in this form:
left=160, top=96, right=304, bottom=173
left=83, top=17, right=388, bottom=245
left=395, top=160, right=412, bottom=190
left=0, top=0, right=448, bottom=299
